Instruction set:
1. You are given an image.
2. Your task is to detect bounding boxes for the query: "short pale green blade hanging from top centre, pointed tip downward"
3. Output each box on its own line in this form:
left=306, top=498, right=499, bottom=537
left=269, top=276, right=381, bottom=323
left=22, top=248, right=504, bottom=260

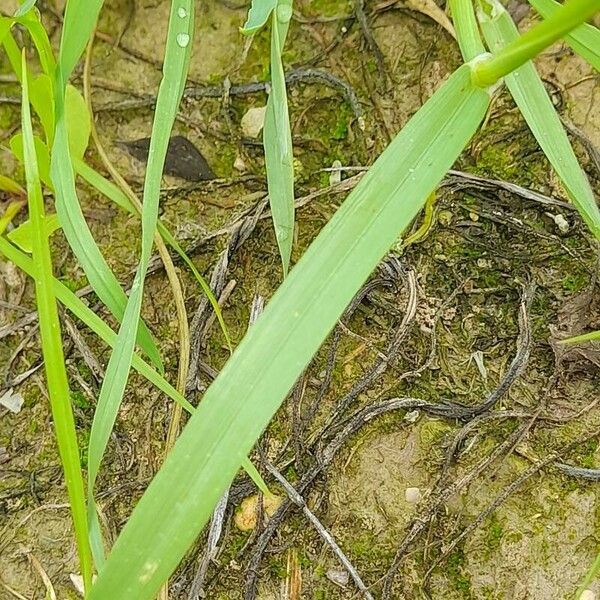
left=263, top=0, right=294, bottom=276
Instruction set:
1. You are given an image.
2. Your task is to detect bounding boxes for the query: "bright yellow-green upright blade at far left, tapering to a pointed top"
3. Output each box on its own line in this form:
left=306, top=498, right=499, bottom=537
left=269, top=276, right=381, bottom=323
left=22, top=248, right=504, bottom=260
left=21, top=52, right=92, bottom=588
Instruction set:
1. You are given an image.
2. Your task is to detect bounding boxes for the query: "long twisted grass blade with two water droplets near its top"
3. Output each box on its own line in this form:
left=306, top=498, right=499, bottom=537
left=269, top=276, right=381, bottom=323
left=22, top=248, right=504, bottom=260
left=88, top=0, right=194, bottom=569
